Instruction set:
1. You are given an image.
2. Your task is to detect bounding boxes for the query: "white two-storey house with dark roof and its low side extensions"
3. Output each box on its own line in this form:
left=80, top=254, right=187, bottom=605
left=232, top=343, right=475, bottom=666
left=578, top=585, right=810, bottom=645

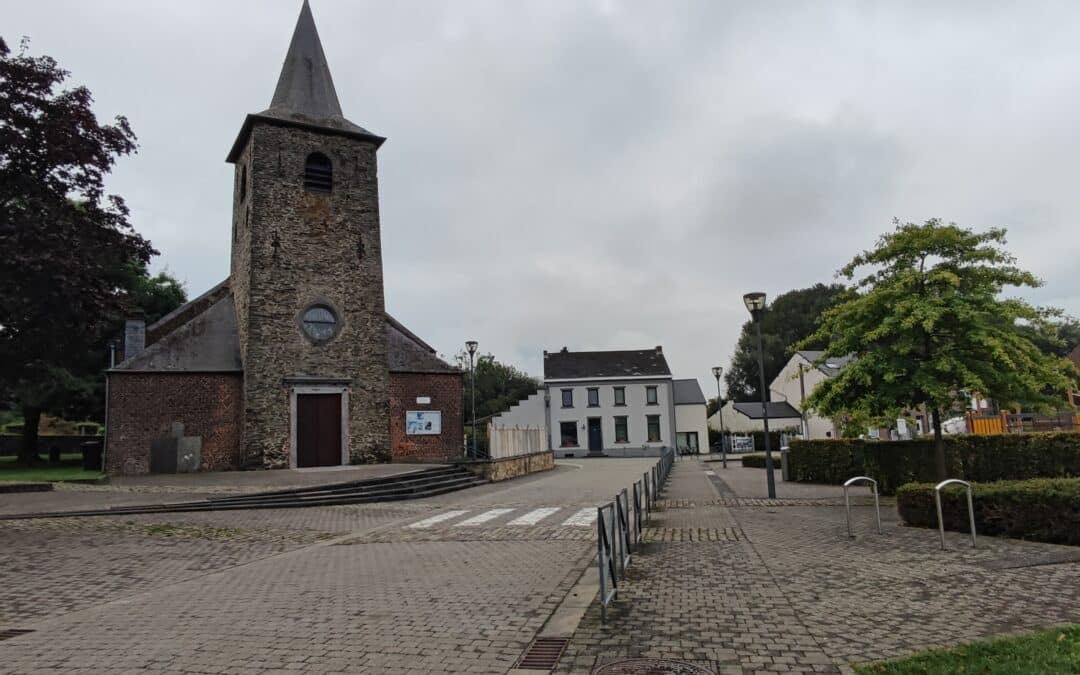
left=491, top=347, right=708, bottom=457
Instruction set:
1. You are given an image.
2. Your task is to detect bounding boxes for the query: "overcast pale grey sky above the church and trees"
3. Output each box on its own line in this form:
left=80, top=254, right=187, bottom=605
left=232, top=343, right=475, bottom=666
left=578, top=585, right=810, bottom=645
left=8, top=0, right=1080, bottom=394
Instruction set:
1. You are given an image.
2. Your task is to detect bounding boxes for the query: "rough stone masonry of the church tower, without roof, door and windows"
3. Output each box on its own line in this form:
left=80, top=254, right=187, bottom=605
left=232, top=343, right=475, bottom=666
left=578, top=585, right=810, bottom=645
left=232, top=122, right=390, bottom=468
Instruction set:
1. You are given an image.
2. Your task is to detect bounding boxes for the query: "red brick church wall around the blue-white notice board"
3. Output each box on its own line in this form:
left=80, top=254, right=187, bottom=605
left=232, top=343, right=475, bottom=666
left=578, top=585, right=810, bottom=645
left=390, top=373, right=464, bottom=461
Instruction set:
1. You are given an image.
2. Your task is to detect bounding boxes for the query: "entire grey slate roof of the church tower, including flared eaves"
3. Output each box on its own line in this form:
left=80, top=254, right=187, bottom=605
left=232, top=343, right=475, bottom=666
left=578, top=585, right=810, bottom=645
left=227, top=0, right=386, bottom=162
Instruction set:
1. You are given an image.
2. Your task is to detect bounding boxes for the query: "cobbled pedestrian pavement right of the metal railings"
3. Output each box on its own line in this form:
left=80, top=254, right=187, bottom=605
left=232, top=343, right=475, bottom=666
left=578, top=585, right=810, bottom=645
left=557, top=461, right=1080, bottom=675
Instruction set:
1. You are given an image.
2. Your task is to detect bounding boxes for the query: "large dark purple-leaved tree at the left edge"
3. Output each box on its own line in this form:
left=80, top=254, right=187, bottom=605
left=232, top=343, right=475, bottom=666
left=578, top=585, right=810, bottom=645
left=0, top=39, right=156, bottom=462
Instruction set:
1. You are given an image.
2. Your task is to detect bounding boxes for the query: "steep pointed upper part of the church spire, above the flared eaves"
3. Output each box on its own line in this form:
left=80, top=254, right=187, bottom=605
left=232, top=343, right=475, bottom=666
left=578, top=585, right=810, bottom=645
left=270, top=0, right=341, bottom=120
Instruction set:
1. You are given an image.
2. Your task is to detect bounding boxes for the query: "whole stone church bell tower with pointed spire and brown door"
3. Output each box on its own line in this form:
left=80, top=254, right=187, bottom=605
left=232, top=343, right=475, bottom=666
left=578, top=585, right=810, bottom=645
left=227, top=0, right=390, bottom=468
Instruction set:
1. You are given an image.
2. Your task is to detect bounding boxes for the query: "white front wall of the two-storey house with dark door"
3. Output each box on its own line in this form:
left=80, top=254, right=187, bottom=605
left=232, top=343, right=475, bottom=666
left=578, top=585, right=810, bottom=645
left=544, top=377, right=675, bottom=457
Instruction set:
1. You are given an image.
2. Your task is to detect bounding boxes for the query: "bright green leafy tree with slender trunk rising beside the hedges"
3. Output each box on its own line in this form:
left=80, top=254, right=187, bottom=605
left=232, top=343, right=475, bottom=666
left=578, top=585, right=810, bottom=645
left=799, top=219, right=1077, bottom=478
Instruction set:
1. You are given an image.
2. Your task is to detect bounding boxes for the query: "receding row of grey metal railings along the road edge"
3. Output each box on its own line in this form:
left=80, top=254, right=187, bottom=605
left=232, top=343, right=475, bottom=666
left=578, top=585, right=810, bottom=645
left=596, top=449, right=675, bottom=622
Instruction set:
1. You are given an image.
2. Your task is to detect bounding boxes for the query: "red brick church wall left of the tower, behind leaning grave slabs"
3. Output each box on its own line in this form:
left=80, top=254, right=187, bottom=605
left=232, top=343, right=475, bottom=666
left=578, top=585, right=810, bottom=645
left=106, top=372, right=243, bottom=474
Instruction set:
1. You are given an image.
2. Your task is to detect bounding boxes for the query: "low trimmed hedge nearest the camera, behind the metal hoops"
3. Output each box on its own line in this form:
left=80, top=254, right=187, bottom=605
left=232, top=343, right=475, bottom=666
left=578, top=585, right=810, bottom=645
left=896, top=478, right=1080, bottom=545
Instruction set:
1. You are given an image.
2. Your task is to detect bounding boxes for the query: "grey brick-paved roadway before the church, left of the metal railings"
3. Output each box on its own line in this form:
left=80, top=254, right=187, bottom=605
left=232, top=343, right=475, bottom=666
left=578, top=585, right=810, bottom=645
left=0, top=460, right=656, bottom=674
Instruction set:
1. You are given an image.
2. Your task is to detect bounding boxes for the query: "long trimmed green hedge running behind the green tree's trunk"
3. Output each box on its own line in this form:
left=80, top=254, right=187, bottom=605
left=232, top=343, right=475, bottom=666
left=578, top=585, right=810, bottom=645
left=787, top=432, right=1080, bottom=495
